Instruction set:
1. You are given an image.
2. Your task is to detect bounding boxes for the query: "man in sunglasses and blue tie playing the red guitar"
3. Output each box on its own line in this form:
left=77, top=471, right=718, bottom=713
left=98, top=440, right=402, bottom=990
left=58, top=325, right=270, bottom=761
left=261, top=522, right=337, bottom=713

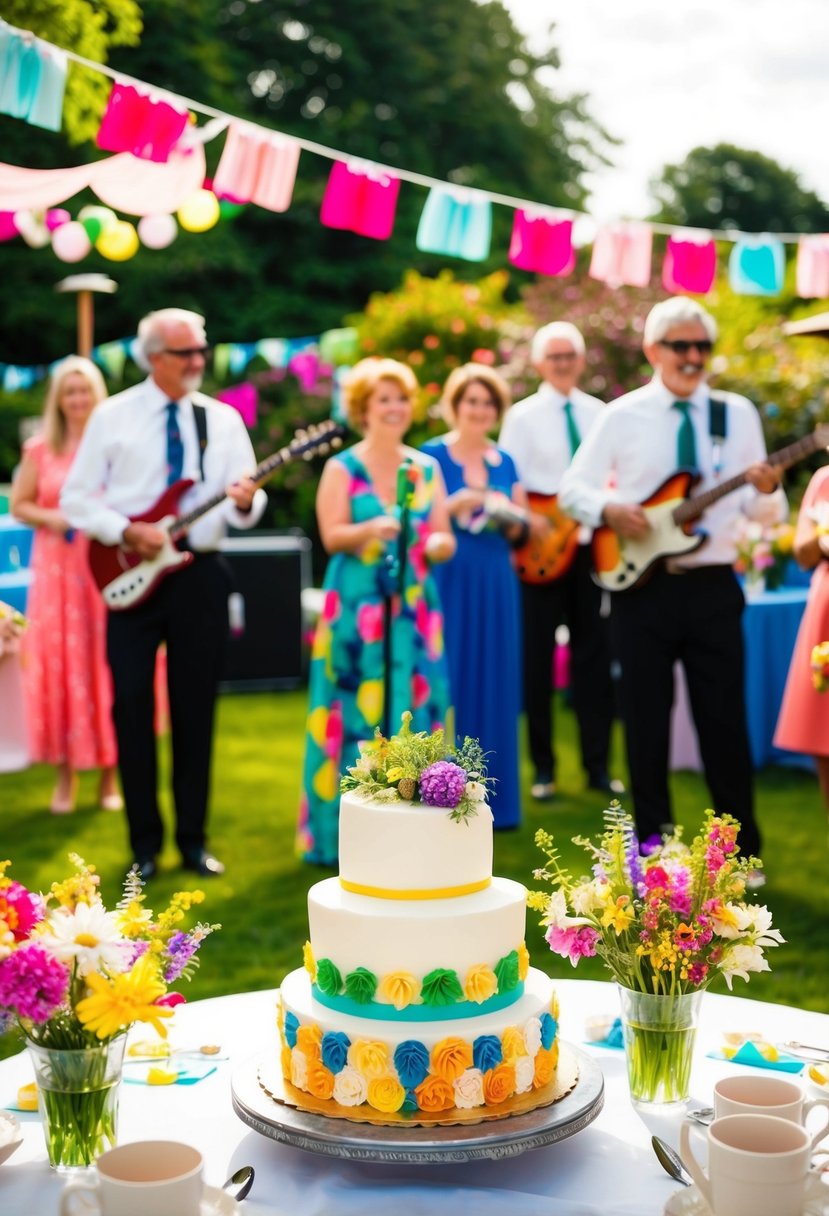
left=61, top=308, right=266, bottom=880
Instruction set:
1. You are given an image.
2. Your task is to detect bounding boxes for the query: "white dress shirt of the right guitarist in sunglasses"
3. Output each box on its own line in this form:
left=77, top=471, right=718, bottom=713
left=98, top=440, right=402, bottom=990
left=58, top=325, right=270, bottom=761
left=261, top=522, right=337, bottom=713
left=560, top=376, right=786, bottom=567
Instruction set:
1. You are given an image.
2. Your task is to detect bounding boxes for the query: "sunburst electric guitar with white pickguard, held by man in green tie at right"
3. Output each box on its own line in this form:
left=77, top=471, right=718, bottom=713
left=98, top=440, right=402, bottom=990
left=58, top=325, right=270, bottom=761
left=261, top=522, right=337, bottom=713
left=593, top=424, right=829, bottom=591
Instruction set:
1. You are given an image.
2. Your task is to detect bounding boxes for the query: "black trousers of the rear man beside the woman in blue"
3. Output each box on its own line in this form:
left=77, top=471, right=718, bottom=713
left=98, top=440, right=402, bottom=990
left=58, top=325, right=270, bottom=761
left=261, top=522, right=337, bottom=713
left=521, top=545, right=615, bottom=779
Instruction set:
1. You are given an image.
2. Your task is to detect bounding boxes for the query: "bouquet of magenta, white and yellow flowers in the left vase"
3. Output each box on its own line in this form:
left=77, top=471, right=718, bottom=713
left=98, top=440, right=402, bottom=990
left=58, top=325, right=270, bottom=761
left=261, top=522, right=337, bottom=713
left=0, top=854, right=219, bottom=1049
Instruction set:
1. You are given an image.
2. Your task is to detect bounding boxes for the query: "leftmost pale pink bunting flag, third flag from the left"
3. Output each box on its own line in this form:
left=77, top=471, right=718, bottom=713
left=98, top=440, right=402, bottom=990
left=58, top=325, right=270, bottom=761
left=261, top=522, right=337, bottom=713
left=213, top=123, right=299, bottom=212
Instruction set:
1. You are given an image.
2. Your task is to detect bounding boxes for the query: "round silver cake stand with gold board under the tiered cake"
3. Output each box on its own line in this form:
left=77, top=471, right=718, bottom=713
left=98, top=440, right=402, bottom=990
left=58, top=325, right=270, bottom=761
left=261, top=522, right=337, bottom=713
left=231, top=1043, right=604, bottom=1162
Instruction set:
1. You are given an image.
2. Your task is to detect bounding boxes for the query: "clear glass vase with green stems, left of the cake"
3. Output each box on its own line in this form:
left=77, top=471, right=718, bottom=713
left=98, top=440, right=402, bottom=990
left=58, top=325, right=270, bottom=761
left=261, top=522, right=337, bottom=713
left=27, top=1035, right=126, bottom=1170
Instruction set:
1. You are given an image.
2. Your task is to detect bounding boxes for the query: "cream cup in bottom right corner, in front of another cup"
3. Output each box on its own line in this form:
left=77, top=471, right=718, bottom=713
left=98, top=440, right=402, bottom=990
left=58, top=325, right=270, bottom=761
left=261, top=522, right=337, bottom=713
left=679, top=1115, right=823, bottom=1216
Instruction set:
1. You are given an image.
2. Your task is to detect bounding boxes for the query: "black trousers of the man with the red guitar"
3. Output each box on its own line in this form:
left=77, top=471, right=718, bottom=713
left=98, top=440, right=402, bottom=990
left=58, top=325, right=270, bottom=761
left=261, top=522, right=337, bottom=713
left=107, top=553, right=230, bottom=858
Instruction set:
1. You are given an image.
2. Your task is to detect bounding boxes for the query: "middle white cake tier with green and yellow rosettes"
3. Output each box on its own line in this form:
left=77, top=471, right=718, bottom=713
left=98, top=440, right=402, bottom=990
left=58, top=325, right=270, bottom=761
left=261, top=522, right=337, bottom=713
left=308, top=878, right=529, bottom=1012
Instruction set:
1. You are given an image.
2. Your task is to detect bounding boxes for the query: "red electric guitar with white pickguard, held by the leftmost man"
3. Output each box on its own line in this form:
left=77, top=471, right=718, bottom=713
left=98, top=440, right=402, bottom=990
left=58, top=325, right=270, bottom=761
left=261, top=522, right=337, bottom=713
left=89, top=422, right=345, bottom=612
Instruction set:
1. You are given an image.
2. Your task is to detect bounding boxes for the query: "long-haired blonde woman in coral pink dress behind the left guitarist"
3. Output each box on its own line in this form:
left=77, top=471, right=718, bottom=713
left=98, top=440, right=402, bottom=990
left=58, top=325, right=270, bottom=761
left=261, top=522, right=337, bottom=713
left=11, top=355, right=123, bottom=815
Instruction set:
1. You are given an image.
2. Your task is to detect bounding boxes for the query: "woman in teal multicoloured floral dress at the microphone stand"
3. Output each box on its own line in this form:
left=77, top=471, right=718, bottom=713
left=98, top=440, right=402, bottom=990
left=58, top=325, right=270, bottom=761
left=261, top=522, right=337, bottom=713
left=298, top=359, right=455, bottom=865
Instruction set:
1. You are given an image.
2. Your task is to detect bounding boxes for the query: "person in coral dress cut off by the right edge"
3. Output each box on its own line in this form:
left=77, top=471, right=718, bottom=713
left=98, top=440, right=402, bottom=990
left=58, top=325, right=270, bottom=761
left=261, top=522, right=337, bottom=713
left=774, top=467, right=829, bottom=810
